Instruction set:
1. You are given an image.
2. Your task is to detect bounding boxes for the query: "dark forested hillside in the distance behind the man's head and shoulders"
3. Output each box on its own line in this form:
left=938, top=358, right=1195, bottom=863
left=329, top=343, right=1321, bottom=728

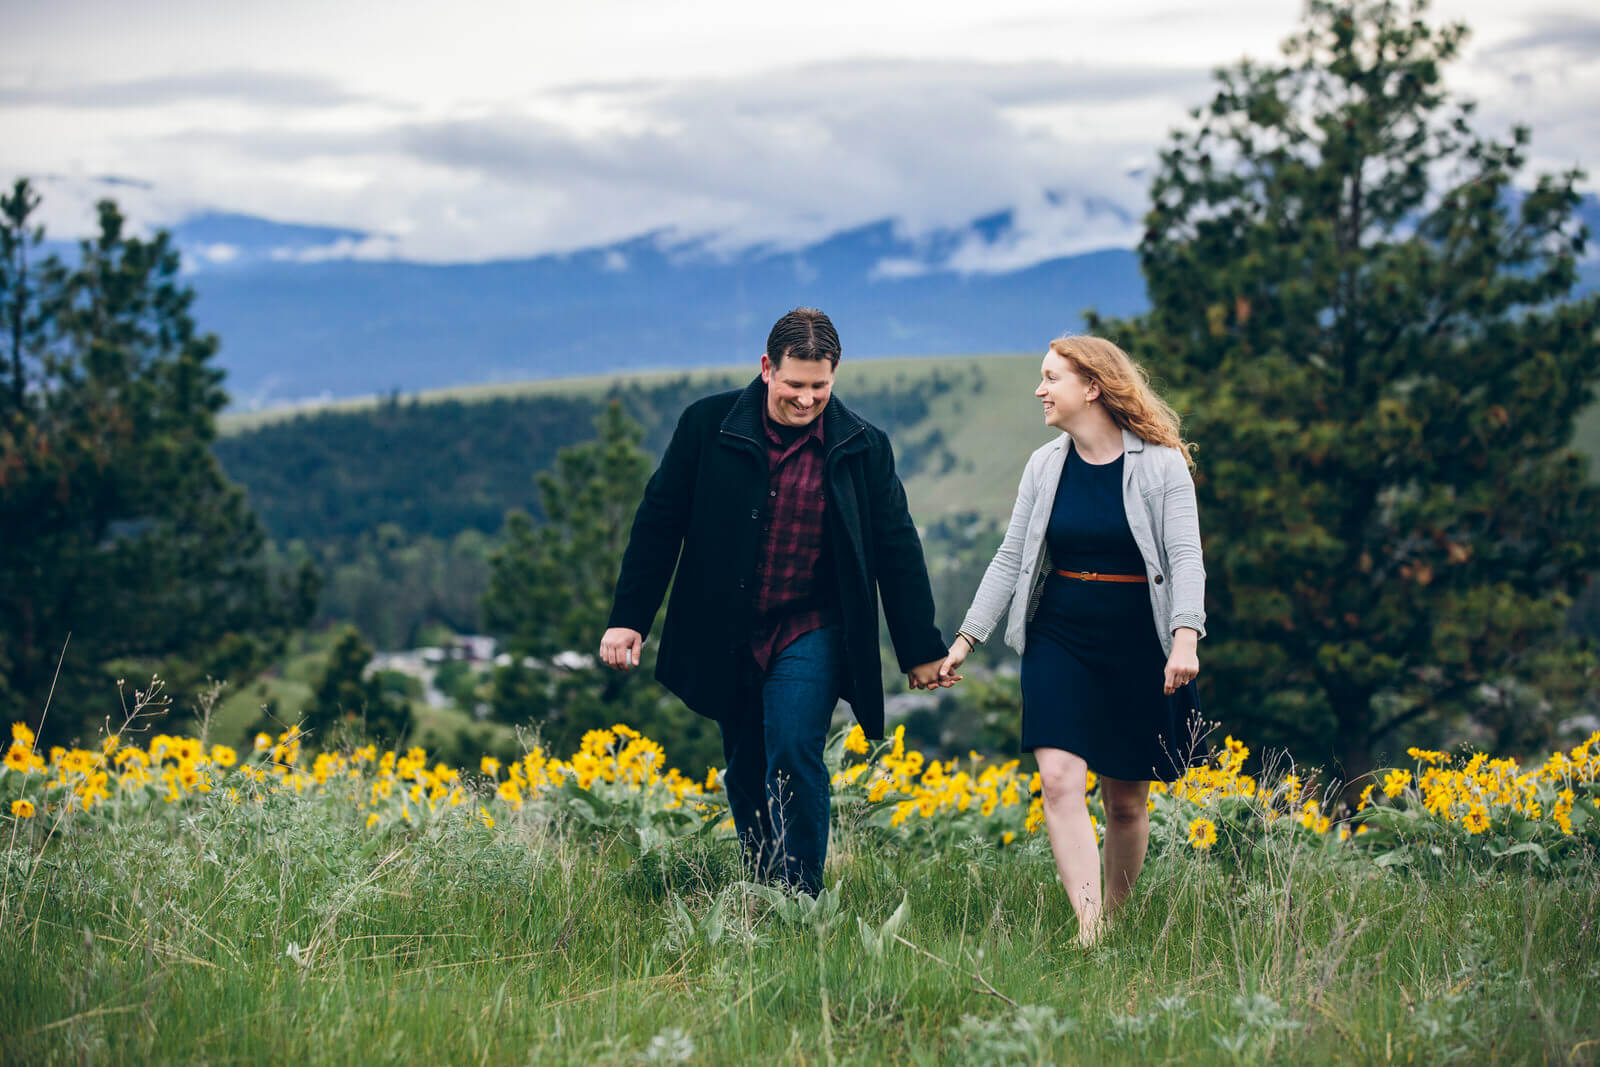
left=214, top=371, right=960, bottom=648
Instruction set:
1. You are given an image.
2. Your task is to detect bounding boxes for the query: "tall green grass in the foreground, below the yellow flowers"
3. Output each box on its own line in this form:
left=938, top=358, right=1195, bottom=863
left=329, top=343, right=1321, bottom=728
left=0, top=795, right=1600, bottom=1064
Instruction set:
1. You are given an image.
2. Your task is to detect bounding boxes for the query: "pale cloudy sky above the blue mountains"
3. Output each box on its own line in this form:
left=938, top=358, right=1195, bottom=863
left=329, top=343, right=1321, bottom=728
left=0, top=0, right=1600, bottom=266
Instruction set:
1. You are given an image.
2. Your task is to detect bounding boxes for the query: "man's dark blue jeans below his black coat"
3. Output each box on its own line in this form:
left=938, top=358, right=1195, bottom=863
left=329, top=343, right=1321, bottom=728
left=722, top=625, right=845, bottom=896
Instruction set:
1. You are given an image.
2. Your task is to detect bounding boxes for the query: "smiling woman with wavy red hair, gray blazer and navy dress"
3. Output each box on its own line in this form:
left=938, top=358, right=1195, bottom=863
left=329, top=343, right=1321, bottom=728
left=941, top=338, right=1205, bottom=944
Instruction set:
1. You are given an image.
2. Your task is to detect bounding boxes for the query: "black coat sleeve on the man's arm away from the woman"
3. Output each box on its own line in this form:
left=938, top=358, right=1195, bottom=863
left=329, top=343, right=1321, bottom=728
left=606, top=408, right=699, bottom=633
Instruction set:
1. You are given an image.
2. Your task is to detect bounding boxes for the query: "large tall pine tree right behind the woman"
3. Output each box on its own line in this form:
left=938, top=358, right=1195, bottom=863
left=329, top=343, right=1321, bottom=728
left=1093, top=0, right=1600, bottom=777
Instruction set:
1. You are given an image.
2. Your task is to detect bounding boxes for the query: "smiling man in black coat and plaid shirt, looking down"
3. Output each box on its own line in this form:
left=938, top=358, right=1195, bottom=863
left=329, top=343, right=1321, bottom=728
left=600, top=307, right=952, bottom=896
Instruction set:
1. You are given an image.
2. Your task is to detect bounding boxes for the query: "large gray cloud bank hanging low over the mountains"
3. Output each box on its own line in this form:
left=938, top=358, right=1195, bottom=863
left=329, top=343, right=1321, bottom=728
left=118, top=59, right=1184, bottom=259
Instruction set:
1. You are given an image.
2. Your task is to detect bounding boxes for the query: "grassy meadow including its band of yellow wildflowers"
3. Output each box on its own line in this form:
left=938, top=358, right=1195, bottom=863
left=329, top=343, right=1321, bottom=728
left=0, top=728, right=1600, bottom=1064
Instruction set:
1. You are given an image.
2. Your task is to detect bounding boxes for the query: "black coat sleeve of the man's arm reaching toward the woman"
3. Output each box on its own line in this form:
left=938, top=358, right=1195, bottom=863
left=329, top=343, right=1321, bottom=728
left=867, top=434, right=946, bottom=673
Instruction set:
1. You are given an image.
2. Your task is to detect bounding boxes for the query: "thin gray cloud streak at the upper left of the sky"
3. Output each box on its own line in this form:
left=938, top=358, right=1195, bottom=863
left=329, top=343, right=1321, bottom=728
left=0, top=70, right=360, bottom=107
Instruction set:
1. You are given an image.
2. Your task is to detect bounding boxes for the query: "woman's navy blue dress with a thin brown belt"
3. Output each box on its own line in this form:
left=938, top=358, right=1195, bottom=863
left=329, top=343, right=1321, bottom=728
left=1022, top=446, right=1198, bottom=782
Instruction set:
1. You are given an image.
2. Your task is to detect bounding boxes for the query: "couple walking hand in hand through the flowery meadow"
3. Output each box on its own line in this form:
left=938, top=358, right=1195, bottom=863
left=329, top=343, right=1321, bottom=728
left=600, top=307, right=1205, bottom=942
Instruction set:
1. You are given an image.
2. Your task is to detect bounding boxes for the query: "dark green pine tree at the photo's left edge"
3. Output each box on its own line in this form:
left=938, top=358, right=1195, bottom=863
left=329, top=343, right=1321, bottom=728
left=0, top=181, right=317, bottom=739
